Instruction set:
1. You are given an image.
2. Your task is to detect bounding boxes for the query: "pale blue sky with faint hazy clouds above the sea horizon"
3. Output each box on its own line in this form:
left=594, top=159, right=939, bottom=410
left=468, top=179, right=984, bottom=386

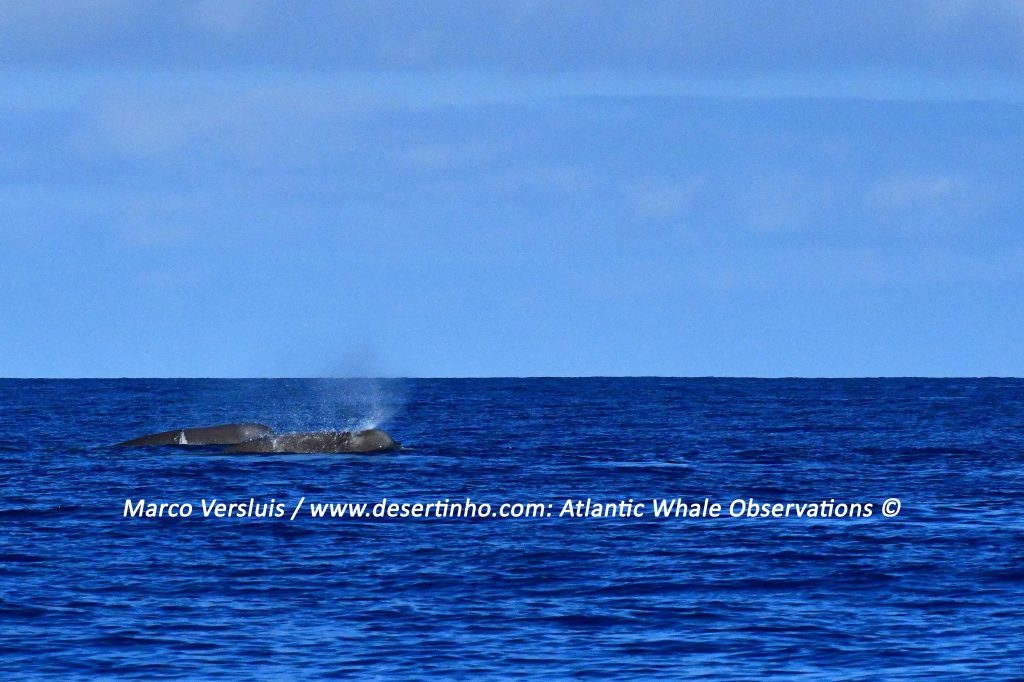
left=0, top=0, right=1024, bottom=377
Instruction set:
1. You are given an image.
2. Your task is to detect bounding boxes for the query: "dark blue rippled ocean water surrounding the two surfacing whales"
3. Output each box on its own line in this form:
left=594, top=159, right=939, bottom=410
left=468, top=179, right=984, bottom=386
left=0, top=379, right=1024, bottom=680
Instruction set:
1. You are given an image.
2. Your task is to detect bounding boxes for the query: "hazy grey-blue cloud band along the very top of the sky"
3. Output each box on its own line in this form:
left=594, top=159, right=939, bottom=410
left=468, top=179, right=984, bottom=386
left=0, top=0, right=1024, bottom=75
